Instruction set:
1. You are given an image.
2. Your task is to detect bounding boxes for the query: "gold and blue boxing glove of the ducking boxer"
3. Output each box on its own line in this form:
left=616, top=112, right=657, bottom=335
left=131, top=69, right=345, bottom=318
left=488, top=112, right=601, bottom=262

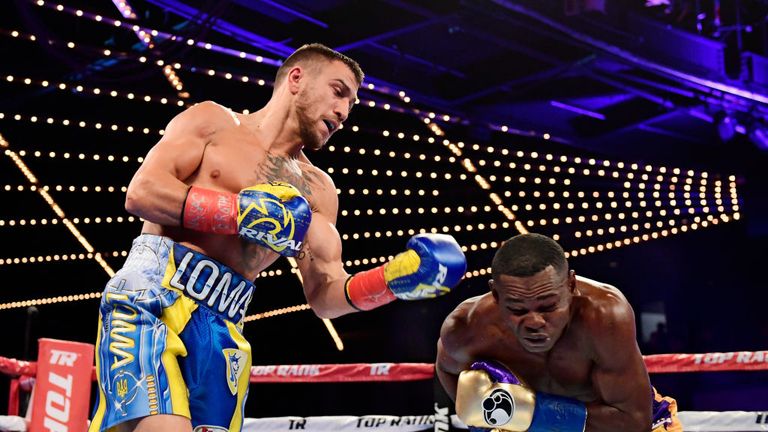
left=456, top=361, right=587, bottom=432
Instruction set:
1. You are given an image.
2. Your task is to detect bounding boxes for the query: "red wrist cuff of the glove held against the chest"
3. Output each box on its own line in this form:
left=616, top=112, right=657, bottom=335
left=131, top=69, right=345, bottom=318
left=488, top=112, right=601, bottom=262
left=181, top=186, right=237, bottom=234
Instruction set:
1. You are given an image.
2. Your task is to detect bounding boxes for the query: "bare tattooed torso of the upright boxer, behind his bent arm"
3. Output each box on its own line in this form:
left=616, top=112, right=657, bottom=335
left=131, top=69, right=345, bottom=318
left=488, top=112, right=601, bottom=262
left=142, top=107, right=333, bottom=280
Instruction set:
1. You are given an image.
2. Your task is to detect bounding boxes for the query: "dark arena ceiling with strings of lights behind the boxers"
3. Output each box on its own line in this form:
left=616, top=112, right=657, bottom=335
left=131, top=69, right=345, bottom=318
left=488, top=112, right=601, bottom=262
left=0, top=0, right=768, bottom=416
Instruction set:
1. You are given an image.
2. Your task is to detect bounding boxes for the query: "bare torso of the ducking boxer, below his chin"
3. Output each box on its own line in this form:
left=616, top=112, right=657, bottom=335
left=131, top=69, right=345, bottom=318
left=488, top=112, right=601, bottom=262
left=453, top=280, right=623, bottom=402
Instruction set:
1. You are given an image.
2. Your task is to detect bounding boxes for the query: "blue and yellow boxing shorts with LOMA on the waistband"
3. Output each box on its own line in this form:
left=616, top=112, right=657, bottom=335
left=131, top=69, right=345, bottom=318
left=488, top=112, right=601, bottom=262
left=89, top=234, right=254, bottom=431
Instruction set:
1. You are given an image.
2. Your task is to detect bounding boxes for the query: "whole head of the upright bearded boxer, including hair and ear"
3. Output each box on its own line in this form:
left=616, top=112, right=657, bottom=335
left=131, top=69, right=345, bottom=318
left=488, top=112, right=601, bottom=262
left=273, top=44, right=364, bottom=150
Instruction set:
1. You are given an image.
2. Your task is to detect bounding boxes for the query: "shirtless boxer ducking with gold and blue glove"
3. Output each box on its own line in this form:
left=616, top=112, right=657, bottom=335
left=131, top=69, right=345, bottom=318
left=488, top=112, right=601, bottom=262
left=436, top=234, right=682, bottom=432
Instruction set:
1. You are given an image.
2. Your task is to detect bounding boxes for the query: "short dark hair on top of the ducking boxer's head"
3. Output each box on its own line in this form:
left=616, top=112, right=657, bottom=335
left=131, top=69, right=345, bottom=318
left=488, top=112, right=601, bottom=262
left=491, top=233, right=568, bottom=279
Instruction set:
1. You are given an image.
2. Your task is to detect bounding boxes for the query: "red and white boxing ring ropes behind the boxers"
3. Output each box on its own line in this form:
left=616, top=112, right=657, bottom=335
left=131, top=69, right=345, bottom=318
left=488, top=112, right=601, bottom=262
left=0, top=351, right=768, bottom=432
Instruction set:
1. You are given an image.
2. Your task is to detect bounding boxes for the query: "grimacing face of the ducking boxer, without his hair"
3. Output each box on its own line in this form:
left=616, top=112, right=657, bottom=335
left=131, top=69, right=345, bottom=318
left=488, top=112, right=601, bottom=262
left=490, top=266, right=575, bottom=352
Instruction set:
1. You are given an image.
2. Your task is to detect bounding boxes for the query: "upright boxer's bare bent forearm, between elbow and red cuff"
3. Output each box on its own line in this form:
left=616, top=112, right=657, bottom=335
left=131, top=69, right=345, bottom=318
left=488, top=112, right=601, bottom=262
left=125, top=174, right=189, bottom=226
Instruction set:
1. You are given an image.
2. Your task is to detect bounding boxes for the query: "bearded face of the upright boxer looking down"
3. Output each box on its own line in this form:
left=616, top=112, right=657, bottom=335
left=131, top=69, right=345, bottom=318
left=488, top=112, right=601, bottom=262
left=296, top=61, right=357, bottom=150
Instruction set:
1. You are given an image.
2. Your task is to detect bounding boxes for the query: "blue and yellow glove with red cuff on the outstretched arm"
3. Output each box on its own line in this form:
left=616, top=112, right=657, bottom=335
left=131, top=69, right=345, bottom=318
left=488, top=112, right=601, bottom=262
left=345, top=234, right=467, bottom=310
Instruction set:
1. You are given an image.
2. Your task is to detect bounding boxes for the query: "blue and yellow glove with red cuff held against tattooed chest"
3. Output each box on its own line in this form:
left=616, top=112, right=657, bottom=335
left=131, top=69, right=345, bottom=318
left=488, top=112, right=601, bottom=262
left=181, top=182, right=312, bottom=257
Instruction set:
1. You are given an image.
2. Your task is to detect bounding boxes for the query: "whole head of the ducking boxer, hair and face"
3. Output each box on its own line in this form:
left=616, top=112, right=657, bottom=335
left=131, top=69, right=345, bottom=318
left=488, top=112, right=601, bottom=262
left=490, top=234, right=576, bottom=352
